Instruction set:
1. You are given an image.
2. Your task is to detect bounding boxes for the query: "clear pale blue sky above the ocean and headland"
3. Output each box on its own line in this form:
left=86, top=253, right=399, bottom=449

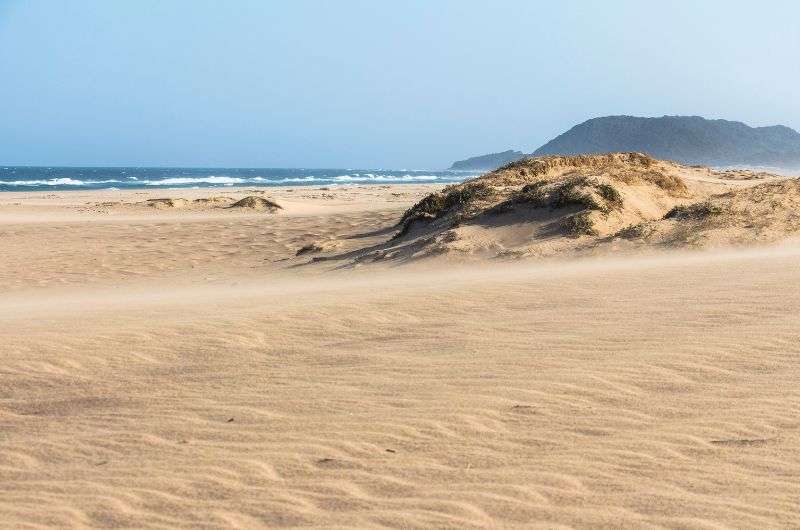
left=0, top=0, right=800, bottom=169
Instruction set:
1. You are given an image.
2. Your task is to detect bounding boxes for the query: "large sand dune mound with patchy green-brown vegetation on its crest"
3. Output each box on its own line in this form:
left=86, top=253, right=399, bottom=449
left=334, top=153, right=800, bottom=263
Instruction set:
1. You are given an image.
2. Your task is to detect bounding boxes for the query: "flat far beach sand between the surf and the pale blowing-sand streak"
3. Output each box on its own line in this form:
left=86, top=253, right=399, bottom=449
left=0, top=184, right=441, bottom=293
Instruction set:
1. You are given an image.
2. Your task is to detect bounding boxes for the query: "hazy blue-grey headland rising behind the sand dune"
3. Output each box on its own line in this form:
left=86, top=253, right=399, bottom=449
left=454, top=116, right=800, bottom=169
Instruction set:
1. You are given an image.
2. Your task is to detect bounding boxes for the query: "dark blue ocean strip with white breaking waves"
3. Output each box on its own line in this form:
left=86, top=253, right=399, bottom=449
left=0, top=166, right=478, bottom=191
